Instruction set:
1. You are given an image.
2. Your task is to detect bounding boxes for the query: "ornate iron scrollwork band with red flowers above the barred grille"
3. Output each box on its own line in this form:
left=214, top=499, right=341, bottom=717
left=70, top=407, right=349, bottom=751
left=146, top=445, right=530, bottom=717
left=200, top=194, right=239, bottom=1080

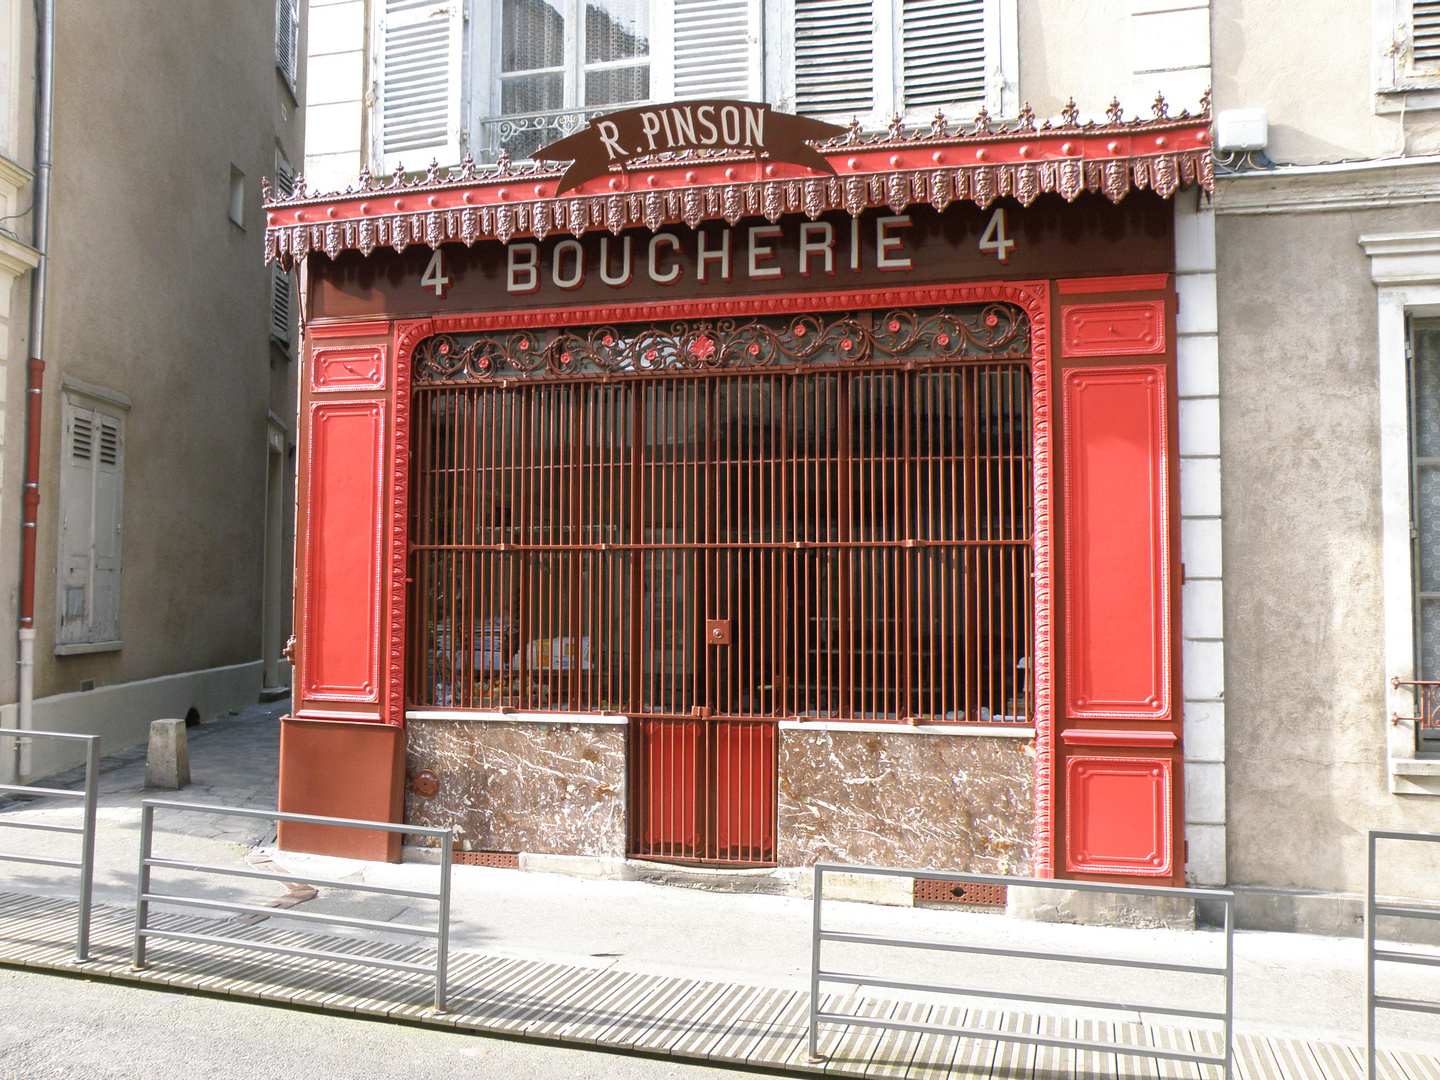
left=413, top=304, right=1030, bottom=384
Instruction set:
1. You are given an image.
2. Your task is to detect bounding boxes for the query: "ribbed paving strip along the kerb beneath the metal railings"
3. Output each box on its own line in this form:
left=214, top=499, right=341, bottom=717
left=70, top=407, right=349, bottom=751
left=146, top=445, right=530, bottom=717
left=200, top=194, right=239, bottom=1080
left=0, top=893, right=1440, bottom=1080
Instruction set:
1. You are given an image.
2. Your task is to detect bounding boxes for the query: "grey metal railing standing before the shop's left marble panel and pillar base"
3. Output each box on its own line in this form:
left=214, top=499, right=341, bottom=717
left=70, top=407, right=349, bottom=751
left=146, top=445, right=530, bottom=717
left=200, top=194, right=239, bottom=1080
left=131, top=799, right=454, bottom=1012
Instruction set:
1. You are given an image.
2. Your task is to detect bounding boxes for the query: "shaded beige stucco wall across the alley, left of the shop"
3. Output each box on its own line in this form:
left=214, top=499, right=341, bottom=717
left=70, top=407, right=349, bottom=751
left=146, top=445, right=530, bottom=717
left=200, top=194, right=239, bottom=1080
left=0, top=0, right=304, bottom=750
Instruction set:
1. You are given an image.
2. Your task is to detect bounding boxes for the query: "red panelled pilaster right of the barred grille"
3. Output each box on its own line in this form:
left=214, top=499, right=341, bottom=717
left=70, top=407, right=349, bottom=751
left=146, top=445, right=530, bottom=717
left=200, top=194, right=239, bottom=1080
left=1054, top=283, right=1185, bottom=883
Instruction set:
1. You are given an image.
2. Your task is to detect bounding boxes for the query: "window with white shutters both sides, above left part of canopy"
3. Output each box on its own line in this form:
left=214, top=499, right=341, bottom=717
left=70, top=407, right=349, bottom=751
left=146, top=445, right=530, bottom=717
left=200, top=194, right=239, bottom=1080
left=372, top=0, right=776, bottom=171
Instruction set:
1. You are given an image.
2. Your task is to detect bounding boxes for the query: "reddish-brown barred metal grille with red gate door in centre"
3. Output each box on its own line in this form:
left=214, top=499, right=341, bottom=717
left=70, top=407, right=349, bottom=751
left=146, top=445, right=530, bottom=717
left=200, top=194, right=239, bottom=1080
left=408, top=305, right=1031, bottom=865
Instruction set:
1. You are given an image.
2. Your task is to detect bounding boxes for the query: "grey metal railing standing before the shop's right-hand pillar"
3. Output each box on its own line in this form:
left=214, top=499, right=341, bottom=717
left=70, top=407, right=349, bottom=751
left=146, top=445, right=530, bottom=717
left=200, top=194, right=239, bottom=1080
left=809, top=863, right=1236, bottom=1080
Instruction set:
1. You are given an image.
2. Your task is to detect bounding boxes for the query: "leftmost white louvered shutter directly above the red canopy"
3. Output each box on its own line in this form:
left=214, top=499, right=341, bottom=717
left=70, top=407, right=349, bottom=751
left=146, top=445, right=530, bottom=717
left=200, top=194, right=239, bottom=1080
left=376, top=0, right=464, bottom=171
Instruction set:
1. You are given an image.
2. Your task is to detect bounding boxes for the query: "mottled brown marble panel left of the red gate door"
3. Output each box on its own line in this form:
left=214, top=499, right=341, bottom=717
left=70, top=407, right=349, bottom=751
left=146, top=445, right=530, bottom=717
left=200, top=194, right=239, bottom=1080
left=405, top=720, right=625, bottom=857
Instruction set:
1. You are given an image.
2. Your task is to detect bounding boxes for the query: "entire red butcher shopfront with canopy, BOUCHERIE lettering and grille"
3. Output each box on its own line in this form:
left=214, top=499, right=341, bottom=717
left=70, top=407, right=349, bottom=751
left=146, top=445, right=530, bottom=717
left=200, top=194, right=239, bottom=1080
left=266, top=107, right=1211, bottom=884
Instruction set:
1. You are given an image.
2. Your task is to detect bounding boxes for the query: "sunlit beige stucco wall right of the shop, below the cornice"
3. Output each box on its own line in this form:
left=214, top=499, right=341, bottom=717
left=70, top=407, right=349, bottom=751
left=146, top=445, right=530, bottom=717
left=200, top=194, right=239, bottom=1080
left=1217, top=201, right=1440, bottom=893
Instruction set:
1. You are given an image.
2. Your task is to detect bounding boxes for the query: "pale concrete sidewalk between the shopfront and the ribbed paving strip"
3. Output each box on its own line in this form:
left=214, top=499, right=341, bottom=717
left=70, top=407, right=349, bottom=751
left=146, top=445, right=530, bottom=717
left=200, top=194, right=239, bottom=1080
left=0, top=703, right=1440, bottom=1050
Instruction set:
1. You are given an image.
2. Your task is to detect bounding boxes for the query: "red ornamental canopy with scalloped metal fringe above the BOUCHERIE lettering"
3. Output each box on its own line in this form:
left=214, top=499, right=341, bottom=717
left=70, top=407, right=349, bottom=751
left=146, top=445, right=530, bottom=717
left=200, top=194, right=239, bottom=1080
left=264, top=92, right=1215, bottom=269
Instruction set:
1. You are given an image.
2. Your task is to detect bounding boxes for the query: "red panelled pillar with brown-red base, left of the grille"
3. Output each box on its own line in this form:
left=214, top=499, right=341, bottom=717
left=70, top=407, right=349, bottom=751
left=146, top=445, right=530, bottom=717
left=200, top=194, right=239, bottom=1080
left=279, top=323, right=408, bottom=861
